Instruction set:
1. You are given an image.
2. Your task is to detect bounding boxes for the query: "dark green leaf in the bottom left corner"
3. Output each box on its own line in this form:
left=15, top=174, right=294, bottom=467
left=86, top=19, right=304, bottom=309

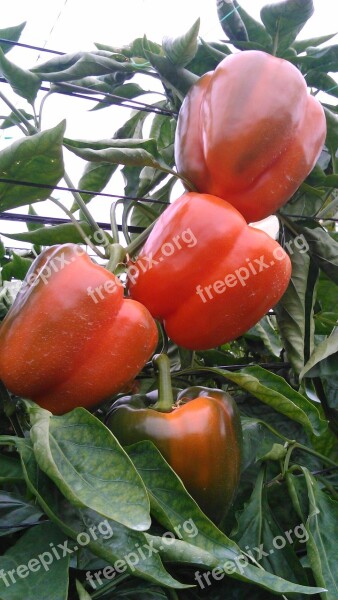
left=0, top=523, right=69, bottom=600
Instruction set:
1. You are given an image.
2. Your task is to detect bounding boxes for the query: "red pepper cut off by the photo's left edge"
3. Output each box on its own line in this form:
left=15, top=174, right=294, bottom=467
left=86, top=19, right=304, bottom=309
left=0, top=244, right=158, bottom=414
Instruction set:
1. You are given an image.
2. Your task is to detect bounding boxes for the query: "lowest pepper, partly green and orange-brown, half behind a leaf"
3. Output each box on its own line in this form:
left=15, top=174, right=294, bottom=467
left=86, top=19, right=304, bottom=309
left=107, top=387, right=242, bottom=523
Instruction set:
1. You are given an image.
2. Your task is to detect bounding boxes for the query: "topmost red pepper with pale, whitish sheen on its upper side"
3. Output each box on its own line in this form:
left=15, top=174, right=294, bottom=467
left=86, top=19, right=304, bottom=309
left=175, top=50, right=326, bottom=222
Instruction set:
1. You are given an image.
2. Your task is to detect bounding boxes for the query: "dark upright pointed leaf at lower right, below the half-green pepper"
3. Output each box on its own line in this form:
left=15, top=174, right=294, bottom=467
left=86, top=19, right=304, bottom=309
left=234, top=469, right=308, bottom=585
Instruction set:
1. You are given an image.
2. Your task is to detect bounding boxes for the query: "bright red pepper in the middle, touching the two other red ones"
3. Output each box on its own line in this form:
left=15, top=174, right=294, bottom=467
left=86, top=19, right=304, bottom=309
left=128, top=193, right=291, bottom=350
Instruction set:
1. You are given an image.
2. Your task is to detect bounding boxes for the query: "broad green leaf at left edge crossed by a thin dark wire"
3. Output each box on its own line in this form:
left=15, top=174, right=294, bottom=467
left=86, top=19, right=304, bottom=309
left=0, top=121, right=66, bottom=211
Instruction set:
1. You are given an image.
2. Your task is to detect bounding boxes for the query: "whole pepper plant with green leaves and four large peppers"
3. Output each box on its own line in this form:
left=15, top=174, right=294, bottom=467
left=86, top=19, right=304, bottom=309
left=0, top=0, right=338, bottom=600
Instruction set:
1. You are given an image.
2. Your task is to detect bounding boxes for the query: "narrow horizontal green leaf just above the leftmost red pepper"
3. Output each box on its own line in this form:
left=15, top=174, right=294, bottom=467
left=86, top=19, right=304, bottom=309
left=0, top=221, right=92, bottom=246
